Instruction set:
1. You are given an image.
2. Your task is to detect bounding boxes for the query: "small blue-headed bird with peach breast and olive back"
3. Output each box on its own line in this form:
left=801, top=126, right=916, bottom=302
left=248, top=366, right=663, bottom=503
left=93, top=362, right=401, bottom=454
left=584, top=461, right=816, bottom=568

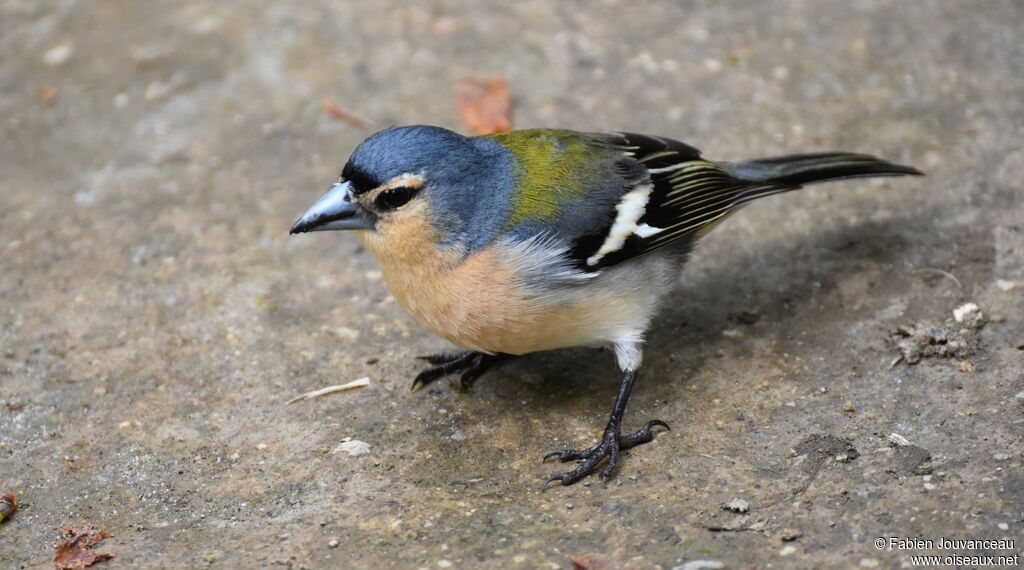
left=291, top=126, right=922, bottom=486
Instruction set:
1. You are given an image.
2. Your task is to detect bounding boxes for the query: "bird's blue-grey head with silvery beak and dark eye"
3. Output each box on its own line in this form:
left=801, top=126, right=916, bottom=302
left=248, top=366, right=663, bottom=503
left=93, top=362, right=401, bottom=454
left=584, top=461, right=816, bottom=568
left=291, top=125, right=513, bottom=251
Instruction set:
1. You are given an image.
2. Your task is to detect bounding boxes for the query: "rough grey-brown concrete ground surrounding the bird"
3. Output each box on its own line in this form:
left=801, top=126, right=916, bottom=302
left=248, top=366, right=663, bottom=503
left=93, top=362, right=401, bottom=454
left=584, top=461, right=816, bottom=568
left=0, top=0, right=1024, bottom=569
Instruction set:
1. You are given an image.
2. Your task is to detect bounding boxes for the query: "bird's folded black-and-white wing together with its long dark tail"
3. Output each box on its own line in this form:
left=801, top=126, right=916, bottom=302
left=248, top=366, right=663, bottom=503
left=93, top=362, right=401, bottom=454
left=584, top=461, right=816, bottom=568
left=572, top=133, right=922, bottom=271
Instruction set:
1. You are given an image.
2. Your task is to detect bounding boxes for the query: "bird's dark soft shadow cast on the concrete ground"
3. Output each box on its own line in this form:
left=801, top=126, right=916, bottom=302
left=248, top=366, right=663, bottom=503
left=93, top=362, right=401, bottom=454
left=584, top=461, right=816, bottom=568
left=474, top=204, right=934, bottom=415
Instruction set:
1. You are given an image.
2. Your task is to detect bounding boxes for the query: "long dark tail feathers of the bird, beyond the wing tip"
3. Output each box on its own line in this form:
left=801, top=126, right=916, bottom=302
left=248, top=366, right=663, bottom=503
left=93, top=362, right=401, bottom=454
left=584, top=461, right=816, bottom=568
left=726, top=152, right=924, bottom=188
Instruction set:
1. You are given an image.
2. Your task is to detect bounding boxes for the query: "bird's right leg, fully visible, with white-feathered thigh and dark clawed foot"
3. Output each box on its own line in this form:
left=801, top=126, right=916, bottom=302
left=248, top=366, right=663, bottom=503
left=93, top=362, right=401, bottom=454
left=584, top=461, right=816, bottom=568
left=544, top=345, right=669, bottom=486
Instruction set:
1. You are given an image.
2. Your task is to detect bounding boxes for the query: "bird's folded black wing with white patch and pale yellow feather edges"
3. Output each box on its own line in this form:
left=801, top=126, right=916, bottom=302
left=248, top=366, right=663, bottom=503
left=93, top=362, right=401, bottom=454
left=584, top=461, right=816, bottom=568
left=571, top=133, right=798, bottom=271
